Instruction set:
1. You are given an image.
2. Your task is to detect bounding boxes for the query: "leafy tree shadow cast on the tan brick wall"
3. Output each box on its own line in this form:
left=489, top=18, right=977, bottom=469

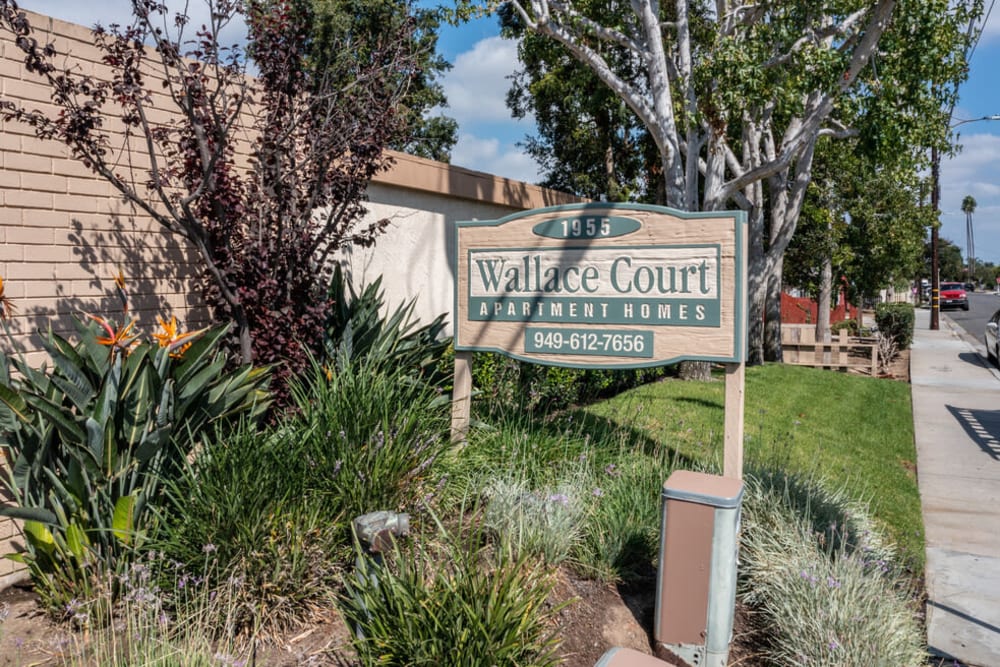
left=12, top=215, right=210, bottom=349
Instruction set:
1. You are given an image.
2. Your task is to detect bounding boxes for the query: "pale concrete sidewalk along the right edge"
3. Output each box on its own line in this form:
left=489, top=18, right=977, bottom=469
left=910, top=310, right=1000, bottom=667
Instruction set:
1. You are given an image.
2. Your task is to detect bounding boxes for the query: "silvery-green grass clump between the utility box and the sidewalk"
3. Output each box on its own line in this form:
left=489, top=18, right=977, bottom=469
left=740, top=470, right=926, bottom=667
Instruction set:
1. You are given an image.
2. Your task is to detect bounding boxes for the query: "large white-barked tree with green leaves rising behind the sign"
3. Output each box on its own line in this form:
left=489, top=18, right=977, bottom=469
left=480, top=0, right=980, bottom=362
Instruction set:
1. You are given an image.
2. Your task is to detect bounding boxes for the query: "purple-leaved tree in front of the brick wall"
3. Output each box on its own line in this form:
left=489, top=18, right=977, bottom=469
left=0, top=0, right=417, bottom=396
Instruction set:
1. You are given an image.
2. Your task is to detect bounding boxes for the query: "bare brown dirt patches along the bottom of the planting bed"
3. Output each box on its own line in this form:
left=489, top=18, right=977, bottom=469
left=0, top=572, right=762, bottom=667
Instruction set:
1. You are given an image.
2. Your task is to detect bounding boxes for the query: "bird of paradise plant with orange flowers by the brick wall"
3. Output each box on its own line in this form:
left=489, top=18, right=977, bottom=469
left=0, top=318, right=268, bottom=610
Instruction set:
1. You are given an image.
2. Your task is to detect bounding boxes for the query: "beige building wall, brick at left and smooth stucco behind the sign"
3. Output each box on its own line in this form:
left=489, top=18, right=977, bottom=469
left=0, top=13, right=574, bottom=588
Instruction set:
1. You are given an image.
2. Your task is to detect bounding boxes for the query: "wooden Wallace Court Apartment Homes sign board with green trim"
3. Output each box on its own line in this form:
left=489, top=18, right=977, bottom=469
left=455, top=203, right=746, bottom=368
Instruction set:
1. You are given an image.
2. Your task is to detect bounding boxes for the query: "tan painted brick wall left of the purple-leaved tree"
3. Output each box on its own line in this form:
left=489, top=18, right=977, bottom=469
left=0, top=13, right=206, bottom=361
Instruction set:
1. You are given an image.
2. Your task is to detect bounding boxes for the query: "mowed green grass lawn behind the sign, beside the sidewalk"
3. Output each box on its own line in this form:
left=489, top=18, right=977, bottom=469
left=584, top=364, right=924, bottom=572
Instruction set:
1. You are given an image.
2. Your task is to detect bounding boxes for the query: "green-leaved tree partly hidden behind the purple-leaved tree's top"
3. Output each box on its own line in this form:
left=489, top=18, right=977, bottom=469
left=310, top=0, right=458, bottom=162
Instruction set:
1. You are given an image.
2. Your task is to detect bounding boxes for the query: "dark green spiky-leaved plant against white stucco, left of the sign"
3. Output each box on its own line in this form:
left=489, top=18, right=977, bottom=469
left=324, top=265, right=449, bottom=383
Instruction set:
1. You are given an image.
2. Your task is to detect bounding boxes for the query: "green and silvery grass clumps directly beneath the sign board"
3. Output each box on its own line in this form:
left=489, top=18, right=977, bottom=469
left=446, top=406, right=672, bottom=582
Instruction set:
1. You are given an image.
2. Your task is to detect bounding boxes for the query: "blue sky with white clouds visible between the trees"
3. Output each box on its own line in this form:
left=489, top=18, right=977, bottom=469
left=22, top=0, right=1000, bottom=264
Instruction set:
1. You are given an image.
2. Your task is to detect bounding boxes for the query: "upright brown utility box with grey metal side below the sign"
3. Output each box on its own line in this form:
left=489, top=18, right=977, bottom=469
left=653, top=470, right=743, bottom=667
